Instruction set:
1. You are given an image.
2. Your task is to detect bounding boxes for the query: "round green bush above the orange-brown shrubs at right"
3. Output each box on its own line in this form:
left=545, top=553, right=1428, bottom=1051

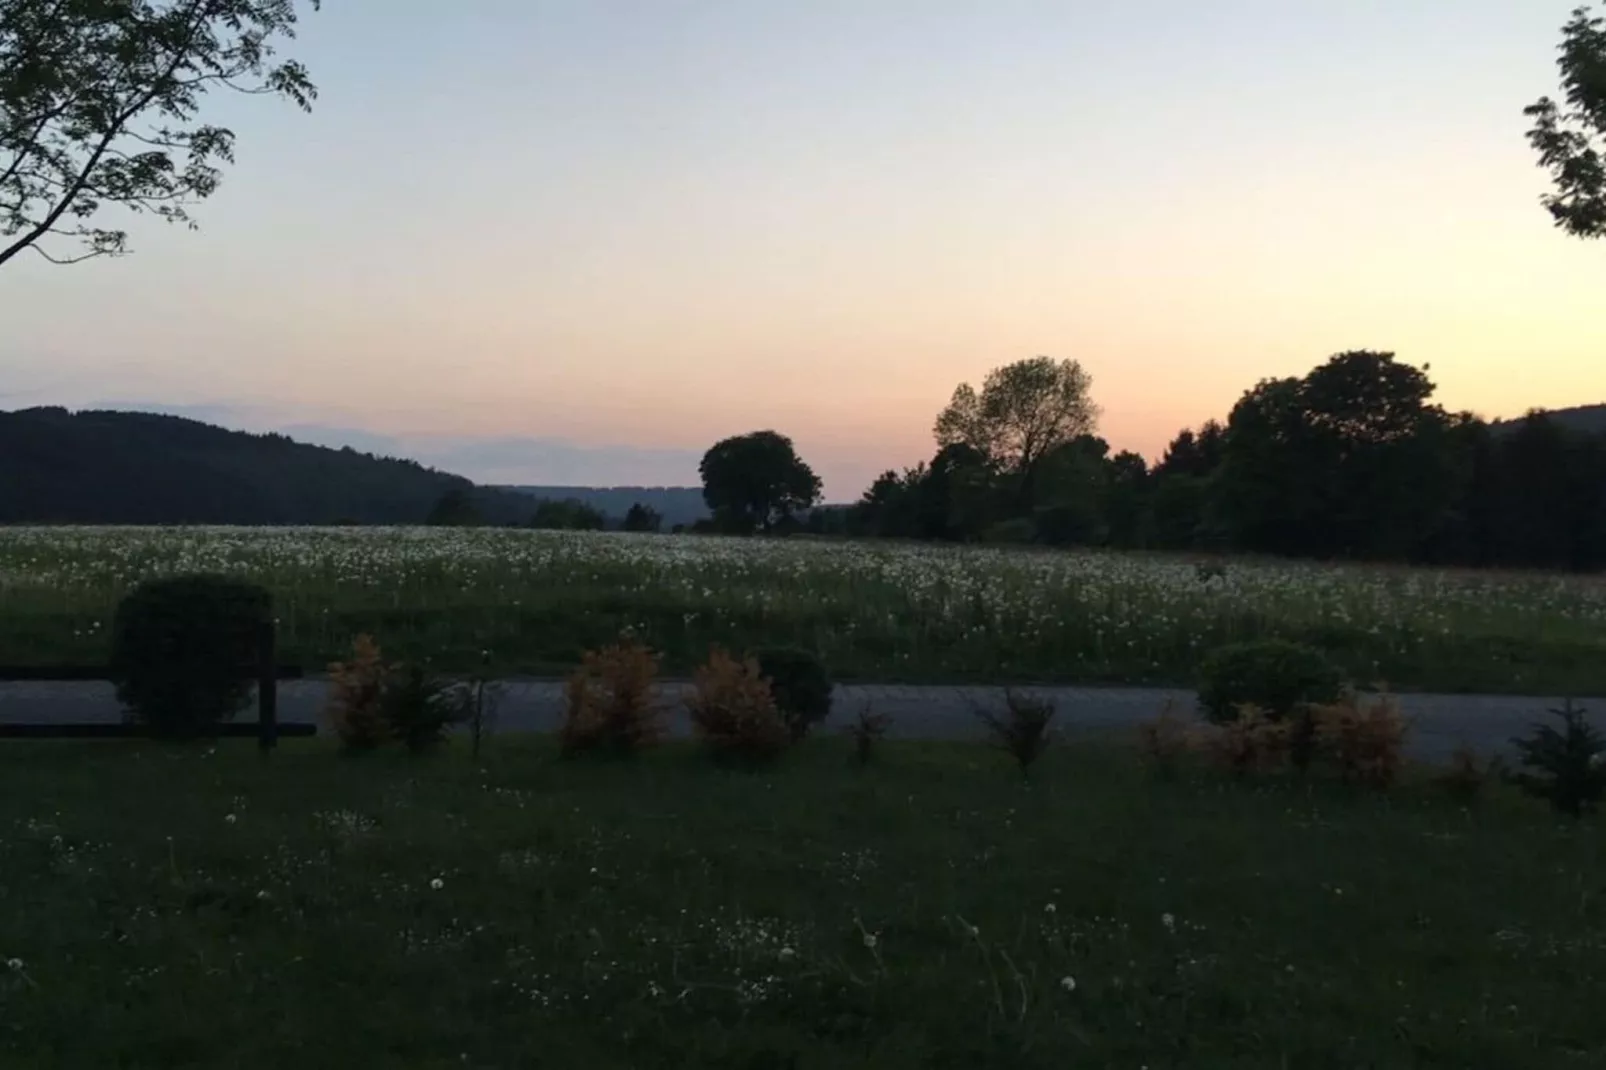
left=1200, top=639, right=1344, bottom=725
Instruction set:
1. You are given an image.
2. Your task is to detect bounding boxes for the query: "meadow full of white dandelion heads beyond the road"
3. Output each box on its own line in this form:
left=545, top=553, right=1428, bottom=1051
left=0, top=527, right=1606, bottom=694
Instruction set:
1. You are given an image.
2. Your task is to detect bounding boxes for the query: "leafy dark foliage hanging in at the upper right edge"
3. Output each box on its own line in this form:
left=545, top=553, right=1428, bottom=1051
left=1524, top=5, right=1606, bottom=238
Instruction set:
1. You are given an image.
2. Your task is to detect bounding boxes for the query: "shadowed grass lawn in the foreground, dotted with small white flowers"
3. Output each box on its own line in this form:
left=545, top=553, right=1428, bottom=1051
left=0, top=741, right=1606, bottom=1070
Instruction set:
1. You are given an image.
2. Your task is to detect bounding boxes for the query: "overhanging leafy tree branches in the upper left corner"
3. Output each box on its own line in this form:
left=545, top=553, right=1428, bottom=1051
left=0, top=0, right=318, bottom=263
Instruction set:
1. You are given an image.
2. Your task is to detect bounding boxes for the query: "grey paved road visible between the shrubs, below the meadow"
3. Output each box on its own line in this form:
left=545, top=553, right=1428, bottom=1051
left=0, top=680, right=1606, bottom=762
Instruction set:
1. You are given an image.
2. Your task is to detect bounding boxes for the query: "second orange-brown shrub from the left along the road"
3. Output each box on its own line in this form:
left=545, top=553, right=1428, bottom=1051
left=557, top=638, right=663, bottom=755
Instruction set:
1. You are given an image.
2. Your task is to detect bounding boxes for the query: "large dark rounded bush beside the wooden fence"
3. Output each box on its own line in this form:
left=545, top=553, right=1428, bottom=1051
left=111, top=575, right=273, bottom=739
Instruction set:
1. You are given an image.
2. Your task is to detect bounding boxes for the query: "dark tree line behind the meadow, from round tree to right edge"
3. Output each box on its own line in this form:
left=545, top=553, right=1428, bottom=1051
left=702, top=350, right=1606, bottom=570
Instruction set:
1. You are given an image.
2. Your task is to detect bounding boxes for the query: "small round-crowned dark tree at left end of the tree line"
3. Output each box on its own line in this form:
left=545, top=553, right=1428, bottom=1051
left=697, top=431, right=821, bottom=533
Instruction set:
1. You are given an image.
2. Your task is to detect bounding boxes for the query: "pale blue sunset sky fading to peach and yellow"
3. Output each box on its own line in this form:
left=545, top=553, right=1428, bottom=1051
left=0, top=0, right=1606, bottom=500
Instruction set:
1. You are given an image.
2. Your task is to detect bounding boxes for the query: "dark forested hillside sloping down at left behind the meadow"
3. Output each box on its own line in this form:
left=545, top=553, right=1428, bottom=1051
left=0, top=408, right=530, bottom=524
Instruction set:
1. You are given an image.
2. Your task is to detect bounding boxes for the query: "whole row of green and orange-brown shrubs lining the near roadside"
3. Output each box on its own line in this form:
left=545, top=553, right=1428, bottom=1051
left=97, top=575, right=1606, bottom=815
